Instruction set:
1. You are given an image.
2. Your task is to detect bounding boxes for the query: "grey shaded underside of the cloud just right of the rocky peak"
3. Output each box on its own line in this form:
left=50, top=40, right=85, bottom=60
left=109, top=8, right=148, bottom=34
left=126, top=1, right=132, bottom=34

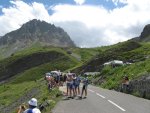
left=55, top=21, right=110, bottom=47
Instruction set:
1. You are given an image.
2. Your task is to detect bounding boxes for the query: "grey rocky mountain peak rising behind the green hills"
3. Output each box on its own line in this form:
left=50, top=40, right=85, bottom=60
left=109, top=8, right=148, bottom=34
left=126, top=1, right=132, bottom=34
left=0, top=19, right=75, bottom=48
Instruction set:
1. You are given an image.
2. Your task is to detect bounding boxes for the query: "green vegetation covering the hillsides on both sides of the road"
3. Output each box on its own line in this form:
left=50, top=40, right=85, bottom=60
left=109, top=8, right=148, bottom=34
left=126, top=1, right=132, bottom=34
left=0, top=41, right=150, bottom=113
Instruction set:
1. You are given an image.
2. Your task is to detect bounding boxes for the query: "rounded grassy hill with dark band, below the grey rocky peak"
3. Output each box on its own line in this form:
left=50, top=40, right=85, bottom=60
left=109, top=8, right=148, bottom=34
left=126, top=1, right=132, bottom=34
left=0, top=47, right=79, bottom=80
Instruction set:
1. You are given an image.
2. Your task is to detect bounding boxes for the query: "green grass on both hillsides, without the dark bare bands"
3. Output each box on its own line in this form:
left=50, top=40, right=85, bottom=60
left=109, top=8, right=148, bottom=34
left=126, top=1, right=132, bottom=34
left=0, top=39, right=150, bottom=113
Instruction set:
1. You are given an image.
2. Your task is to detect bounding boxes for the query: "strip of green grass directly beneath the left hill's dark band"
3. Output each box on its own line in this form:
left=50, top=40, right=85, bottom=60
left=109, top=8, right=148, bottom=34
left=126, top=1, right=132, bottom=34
left=12, top=55, right=77, bottom=83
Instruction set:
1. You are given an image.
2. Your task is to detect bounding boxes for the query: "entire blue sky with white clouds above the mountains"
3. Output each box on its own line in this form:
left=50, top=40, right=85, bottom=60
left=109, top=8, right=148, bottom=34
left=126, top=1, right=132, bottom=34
left=0, top=0, right=150, bottom=47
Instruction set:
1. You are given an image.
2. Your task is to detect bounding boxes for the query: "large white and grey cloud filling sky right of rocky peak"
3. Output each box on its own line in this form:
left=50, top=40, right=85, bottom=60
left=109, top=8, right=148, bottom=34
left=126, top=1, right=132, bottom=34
left=48, top=0, right=150, bottom=47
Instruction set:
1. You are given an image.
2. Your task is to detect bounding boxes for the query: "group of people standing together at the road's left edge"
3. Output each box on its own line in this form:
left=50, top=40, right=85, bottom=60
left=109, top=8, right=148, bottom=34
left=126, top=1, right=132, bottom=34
left=45, top=71, right=89, bottom=99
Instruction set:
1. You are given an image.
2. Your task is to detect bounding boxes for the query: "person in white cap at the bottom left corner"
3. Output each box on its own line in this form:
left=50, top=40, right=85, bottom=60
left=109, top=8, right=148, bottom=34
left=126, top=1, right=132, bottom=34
left=18, top=98, right=41, bottom=113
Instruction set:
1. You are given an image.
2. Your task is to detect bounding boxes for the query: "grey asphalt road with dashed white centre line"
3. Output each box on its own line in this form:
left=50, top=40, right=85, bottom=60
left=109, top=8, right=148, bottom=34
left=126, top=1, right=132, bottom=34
left=52, top=86, right=150, bottom=113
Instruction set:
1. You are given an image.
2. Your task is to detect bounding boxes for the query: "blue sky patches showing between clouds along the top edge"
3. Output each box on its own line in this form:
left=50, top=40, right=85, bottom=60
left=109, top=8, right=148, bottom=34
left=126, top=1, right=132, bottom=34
left=0, top=0, right=126, bottom=14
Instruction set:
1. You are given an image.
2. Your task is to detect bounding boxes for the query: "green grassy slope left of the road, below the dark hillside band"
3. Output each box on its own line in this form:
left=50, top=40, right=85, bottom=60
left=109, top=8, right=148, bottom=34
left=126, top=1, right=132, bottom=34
left=0, top=59, right=75, bottom=113
